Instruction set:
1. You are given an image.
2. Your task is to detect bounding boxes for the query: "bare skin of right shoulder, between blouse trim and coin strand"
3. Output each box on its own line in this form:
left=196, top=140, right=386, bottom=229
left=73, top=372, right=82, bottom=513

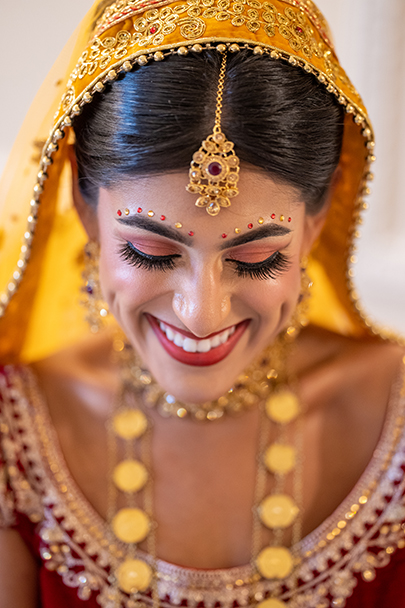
left=292, top=327, right=405, bottom=533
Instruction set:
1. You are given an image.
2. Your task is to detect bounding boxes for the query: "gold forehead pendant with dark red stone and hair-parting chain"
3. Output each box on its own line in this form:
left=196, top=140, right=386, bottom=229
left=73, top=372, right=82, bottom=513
left=186, top=54, right=239, bottom=215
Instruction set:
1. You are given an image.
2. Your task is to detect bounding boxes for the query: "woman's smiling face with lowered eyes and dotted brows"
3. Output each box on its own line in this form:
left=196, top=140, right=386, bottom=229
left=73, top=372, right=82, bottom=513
left=82, top=167, right=322, bottom=403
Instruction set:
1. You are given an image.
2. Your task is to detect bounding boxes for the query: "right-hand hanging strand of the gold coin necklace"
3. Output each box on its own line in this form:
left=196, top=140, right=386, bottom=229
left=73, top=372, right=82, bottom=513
left=252, top=328, right=302, bottom=608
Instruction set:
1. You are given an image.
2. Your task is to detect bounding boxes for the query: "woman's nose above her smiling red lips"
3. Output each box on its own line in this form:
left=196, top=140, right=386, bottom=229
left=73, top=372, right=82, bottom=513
left=172, top=266, right=231, bottom=338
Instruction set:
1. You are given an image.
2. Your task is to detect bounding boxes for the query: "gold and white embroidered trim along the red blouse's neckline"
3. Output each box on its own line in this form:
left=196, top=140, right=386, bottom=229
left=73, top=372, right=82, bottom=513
left=0, top=368, right=405, bottom=608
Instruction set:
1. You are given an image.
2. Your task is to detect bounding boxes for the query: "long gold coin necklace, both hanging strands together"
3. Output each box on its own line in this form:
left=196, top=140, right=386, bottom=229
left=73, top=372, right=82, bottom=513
left=108, top=340, right=302, bottom=608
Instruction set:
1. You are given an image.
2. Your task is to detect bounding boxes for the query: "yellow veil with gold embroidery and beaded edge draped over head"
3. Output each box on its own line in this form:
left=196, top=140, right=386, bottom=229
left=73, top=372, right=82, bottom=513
left=0, top=0, right=393, bottom=362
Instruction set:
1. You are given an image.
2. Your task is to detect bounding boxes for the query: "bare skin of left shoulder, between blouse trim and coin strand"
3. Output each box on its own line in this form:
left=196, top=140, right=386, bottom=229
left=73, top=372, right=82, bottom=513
left=28, top=334, right=119, bottom=516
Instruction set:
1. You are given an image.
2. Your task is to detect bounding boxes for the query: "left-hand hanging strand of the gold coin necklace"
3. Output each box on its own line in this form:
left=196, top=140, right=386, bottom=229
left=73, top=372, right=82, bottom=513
left=107, top=382, right=158, bottom=606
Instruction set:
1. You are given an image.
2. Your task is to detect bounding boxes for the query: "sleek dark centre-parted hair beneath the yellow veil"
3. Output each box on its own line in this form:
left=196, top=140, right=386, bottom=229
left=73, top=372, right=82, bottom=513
left=74, top=50, right=343, bottom=213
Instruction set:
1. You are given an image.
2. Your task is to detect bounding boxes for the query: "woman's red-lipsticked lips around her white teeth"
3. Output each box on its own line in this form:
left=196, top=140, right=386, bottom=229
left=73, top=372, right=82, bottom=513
left=145, top=313, right=250, bottom=367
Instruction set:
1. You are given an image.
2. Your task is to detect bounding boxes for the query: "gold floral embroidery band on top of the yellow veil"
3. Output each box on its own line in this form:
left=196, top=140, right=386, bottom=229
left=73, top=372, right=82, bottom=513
left=69, top=0, right=334, bottom=83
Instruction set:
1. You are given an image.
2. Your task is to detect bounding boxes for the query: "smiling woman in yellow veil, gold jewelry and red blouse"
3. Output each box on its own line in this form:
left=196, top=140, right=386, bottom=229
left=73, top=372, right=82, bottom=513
left=0, top=0, right=405, bottom=608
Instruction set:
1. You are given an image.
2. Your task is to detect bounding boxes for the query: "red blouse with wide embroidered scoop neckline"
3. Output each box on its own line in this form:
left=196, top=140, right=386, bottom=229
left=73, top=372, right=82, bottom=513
left=0, top=367, right=405, bottom=608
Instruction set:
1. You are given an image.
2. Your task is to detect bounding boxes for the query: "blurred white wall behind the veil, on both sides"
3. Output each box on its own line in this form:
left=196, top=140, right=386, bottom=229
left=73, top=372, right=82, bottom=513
left=0, top=0, right=405, bottom=333
